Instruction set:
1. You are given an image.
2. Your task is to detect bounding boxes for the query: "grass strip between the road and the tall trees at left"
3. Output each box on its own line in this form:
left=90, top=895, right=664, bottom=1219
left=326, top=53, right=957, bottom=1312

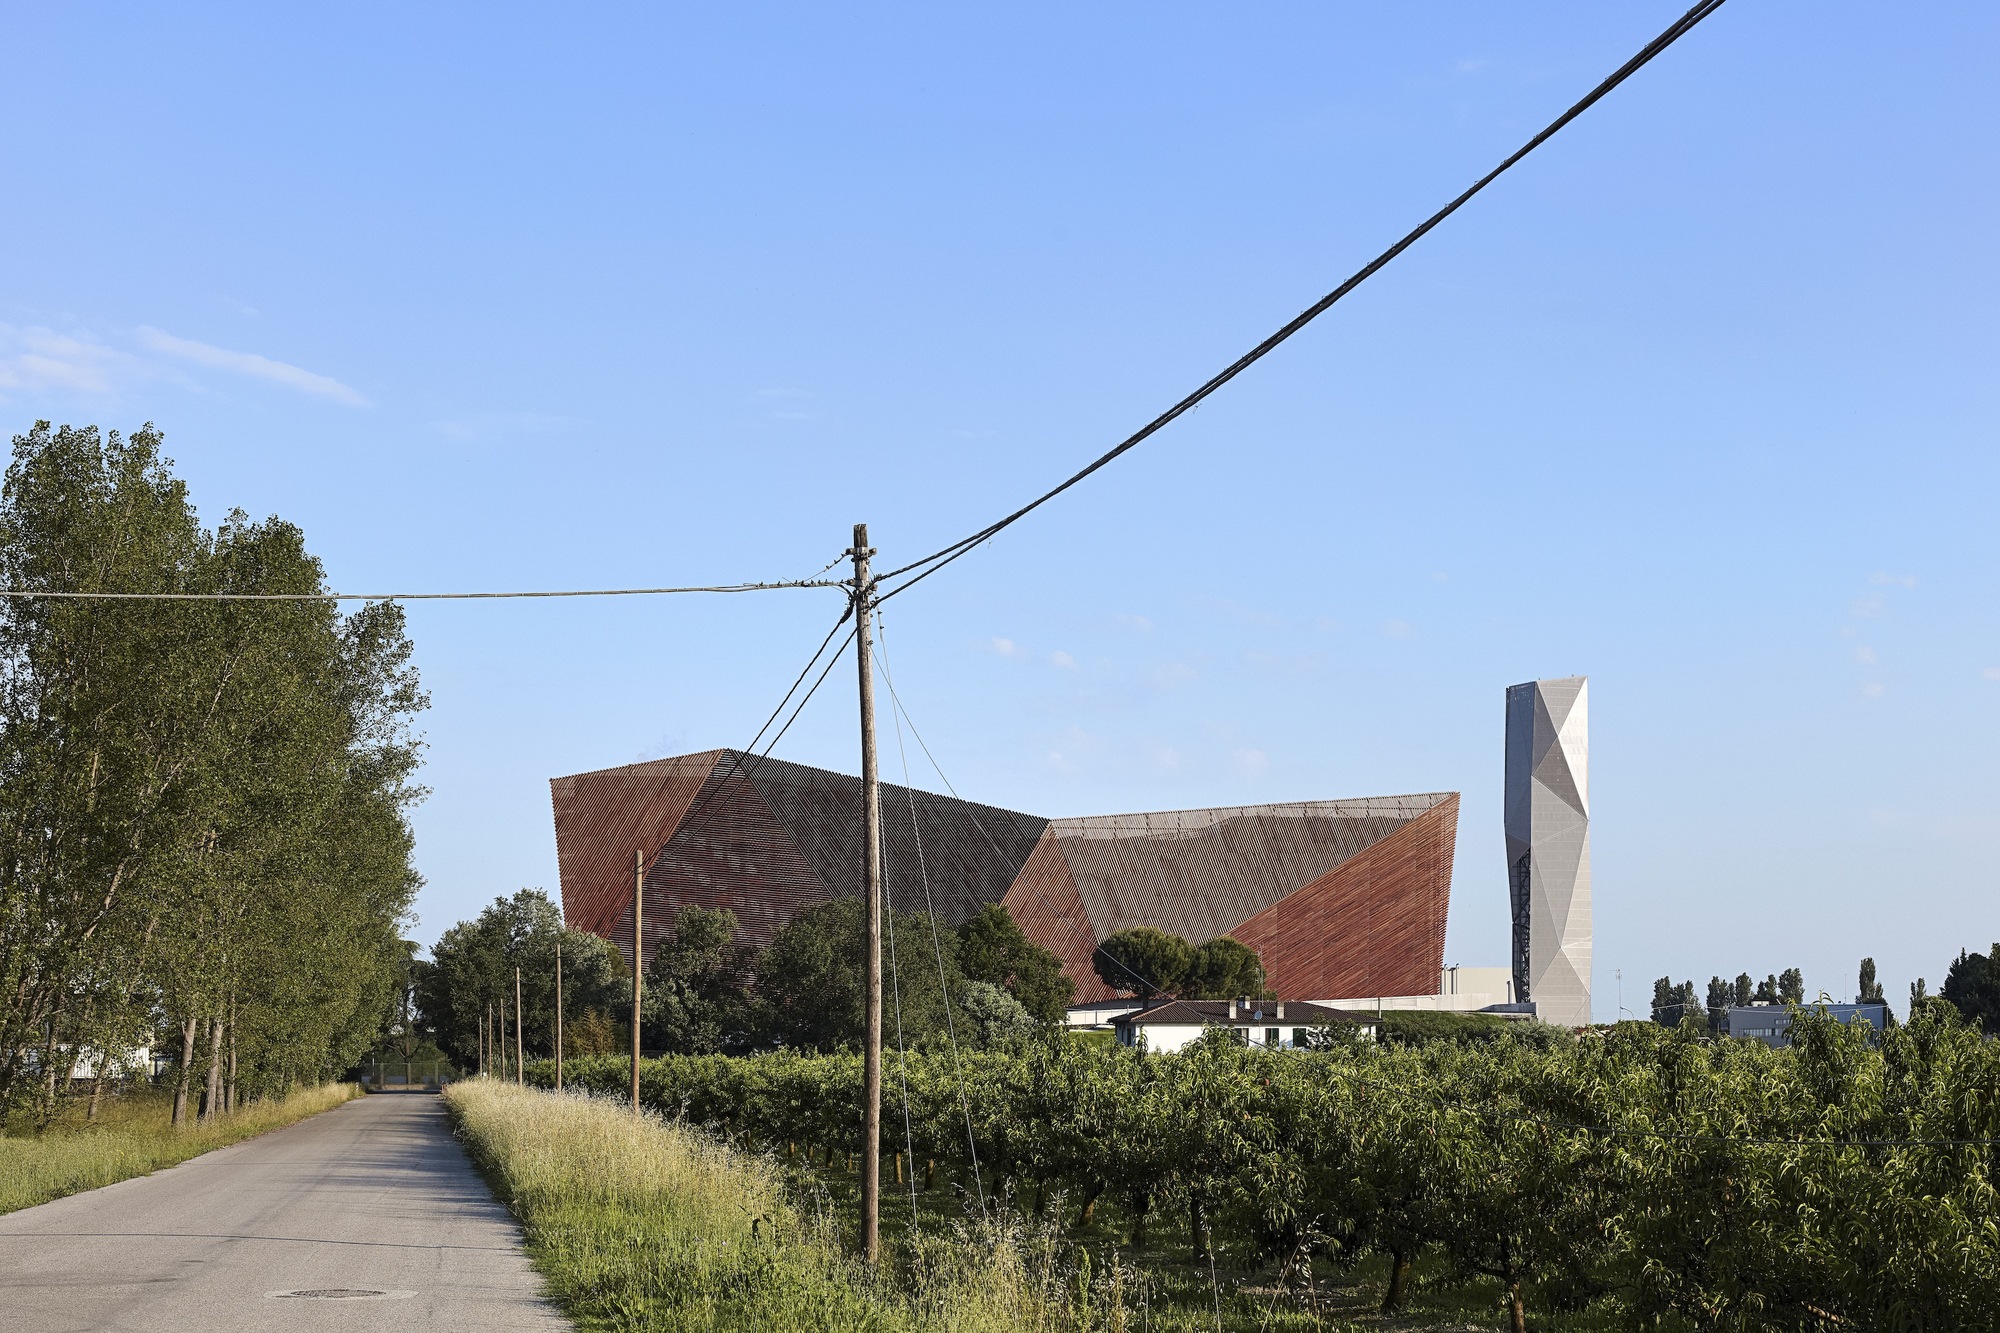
left=0, top=1083, right=360, bottom=1213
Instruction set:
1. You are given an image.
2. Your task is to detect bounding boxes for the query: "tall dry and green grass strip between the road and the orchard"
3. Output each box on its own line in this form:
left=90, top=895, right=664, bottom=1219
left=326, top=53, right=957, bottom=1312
left=446, top=1081, right=1138, bottom=1333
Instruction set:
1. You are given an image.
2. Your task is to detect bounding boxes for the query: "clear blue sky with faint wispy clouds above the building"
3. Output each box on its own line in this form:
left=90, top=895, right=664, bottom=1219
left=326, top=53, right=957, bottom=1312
left=0, top=0, right=2000, bottom=1017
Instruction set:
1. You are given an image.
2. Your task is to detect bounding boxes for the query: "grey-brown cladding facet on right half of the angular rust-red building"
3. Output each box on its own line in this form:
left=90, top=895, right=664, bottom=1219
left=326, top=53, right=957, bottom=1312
left=1050, top=793, right=1450, bottom=943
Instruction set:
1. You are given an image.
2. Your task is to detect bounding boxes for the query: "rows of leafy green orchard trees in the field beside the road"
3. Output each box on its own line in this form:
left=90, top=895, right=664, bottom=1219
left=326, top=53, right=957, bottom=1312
left=528, top=999, right=2000, bottom=1333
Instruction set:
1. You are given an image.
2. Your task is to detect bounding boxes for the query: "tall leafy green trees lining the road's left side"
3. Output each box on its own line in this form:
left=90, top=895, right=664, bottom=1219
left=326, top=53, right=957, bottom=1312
left=0, top=422, right=426, bottom=1123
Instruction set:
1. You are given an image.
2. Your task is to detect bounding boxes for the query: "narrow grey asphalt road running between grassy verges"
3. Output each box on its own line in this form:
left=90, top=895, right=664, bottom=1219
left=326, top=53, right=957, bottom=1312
left=0, top=1093, right=570, bottom=1333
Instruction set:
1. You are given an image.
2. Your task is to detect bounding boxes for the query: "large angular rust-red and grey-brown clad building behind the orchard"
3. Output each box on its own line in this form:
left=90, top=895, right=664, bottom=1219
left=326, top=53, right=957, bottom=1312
left=550, top=751, right=1458, bottom=1001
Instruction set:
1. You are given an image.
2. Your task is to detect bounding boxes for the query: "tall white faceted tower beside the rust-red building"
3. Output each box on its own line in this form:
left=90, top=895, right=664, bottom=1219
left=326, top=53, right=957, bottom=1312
left=1506, top=677, right=1590, bottom=1027
